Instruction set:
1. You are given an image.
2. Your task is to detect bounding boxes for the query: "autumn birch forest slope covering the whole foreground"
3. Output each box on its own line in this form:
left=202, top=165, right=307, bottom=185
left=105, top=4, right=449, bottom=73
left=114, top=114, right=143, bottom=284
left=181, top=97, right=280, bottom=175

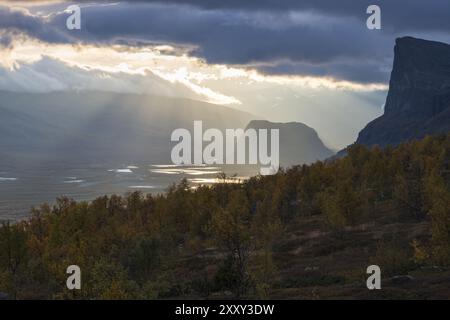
left=0, top=134, right=450, bottom=299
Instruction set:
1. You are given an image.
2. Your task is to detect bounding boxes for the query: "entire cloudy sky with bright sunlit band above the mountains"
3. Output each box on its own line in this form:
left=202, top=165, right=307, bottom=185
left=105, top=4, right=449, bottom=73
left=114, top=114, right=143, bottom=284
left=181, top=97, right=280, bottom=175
left=0, top=0, right=450, bottom=149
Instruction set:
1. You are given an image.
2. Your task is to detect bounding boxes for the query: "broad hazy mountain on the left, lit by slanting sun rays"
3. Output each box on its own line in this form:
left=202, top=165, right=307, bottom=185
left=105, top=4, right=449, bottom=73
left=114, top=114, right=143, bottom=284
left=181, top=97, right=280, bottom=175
left=0, top=91, right=254, bottom=166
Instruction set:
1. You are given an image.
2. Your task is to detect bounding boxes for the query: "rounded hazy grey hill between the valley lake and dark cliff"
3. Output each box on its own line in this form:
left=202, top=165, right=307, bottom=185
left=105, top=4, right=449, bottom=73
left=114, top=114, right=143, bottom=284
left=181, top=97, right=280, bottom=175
left=247, top=120, right=334, bottom=167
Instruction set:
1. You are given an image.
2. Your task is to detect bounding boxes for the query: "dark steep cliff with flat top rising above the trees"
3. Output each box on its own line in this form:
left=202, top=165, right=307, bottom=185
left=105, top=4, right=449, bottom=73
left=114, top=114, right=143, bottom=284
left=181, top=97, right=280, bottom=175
left=356, top=37, right=450, bottom=146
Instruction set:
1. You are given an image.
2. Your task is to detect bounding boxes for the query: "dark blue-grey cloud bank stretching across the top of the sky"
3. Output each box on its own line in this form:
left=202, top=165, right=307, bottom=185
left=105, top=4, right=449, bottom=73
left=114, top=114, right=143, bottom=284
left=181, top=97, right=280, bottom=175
left=0, top=0, right=450, bottom=82
